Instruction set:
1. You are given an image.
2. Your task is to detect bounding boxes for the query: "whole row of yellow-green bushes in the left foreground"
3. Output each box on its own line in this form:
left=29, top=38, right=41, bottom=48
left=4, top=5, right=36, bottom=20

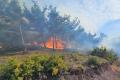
left=0, top=56, right=66, bottom=80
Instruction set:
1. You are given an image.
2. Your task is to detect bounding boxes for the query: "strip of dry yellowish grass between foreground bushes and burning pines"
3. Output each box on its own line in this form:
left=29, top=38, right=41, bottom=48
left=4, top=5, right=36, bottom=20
left=0, top=49, right=107, bottom=66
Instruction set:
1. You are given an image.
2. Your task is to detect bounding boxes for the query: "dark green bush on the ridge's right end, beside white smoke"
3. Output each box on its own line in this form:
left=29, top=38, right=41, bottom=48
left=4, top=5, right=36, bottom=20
left=90, top=47, right=118, bottom=63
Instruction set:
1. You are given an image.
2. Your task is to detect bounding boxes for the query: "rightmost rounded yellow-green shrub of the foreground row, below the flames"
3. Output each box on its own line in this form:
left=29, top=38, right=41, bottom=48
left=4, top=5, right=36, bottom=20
left=44, top=56, right=67, bottom=77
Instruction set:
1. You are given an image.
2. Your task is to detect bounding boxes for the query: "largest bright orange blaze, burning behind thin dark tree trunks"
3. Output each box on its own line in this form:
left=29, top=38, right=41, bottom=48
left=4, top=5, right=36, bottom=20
left=46, top=37, right=65, bottom=50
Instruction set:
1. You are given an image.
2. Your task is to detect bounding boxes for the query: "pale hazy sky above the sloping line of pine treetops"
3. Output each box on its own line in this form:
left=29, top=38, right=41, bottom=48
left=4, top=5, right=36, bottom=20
left=27, top=0, right=120, bottom=36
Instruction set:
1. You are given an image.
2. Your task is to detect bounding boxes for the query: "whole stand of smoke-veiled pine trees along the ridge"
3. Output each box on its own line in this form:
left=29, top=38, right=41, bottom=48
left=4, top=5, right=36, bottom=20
left=0, top=0, right=104, bottom=50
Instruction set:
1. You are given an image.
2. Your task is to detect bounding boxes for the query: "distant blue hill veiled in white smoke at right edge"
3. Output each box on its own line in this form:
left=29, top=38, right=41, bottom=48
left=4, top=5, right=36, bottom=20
left=101, top=20, right=120, bottom=54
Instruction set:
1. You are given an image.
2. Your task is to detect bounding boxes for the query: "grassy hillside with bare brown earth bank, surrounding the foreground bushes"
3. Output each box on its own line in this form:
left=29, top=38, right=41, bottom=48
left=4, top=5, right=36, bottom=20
left=0, top=49, right=119, bottom=80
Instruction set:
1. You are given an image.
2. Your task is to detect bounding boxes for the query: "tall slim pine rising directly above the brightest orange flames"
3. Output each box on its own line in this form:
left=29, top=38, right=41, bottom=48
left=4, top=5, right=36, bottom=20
left=48, top=7, right=64, bottom=50
